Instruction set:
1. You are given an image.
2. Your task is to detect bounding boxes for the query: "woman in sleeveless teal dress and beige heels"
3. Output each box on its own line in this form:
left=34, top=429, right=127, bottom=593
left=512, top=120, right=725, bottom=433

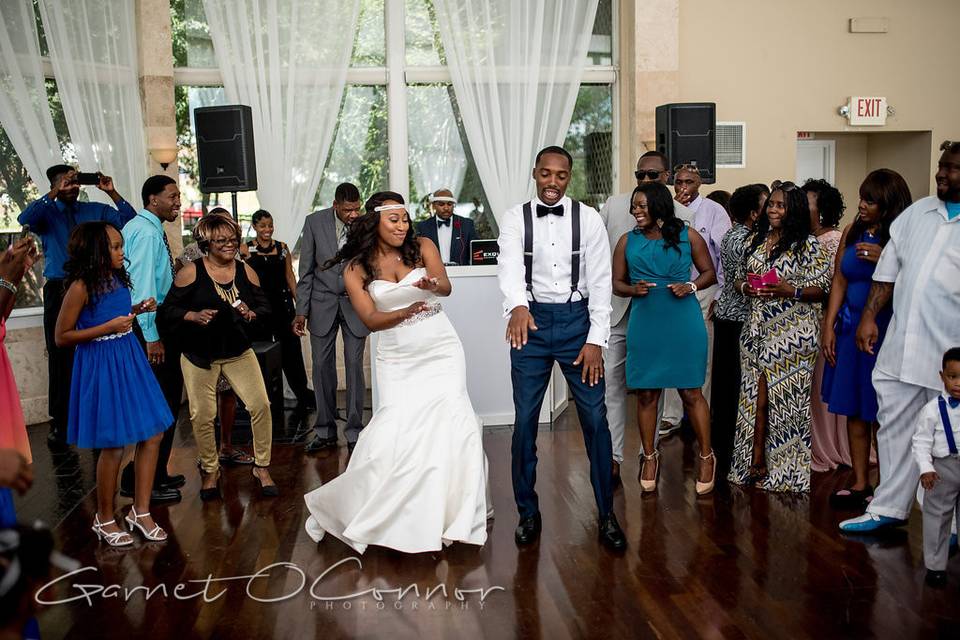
left=613, top=182, right=717, bottom=495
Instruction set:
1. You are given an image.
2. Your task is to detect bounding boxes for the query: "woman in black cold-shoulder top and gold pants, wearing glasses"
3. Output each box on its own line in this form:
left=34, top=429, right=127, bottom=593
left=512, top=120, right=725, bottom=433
left=158, top=215, right=278, bottom=501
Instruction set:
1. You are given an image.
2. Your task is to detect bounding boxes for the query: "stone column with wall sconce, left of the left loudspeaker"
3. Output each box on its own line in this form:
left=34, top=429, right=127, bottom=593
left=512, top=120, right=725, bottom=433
left=132, top=0, right=183, bottom=257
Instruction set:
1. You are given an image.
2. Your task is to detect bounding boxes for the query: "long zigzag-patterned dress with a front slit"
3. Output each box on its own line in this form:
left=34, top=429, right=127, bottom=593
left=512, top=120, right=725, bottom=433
left=729, top=236, right=830, bottom=492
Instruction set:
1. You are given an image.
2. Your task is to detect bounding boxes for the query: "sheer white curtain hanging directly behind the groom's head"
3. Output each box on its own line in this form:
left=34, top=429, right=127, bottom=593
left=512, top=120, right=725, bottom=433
left=434, top=0, right=598, bottom=221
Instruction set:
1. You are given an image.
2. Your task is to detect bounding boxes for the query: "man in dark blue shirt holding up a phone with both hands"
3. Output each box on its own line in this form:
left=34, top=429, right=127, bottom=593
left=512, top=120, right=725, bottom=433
left=17, top=164, right=137, bottom=447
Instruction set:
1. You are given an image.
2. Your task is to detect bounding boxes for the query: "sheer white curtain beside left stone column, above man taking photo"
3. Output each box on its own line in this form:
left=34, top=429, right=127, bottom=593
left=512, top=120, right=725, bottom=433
left=39, top=0, right=148, bottom=207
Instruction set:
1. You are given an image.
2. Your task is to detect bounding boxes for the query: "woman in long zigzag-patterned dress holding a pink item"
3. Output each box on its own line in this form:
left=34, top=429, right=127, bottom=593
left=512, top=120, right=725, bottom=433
left=729, top=180, right=830, bottom=492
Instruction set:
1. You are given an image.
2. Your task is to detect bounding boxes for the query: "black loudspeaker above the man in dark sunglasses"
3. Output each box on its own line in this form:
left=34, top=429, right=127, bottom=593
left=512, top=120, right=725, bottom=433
left=657, top=102, right=717, bottom=184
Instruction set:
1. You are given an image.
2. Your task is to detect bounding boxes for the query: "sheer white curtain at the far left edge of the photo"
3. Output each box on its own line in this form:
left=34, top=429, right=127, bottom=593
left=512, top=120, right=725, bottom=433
left=0, top=0, right=63, bottom=193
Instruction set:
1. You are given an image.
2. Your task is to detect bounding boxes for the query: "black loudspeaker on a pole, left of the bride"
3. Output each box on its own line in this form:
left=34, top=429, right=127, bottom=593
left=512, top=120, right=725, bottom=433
left=193, top=104, right=257, bottom=193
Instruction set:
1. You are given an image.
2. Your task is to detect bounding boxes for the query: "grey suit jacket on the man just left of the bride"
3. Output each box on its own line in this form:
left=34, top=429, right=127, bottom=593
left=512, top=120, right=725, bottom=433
left=297, top=207, right=370, bottom=337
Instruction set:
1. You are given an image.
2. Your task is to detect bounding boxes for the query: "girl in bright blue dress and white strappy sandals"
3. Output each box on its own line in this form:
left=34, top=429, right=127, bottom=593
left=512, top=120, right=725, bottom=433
left=56, top=222, right=173, bottom=547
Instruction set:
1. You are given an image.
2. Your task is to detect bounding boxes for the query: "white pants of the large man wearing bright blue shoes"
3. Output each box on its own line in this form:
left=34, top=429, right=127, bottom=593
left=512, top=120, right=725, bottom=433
left=867, top=367, right=939, bottom=520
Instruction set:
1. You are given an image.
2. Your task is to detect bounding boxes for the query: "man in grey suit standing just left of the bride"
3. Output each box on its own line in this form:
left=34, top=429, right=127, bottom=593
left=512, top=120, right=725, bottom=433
left=293, top=182, right=370, bottom=453
